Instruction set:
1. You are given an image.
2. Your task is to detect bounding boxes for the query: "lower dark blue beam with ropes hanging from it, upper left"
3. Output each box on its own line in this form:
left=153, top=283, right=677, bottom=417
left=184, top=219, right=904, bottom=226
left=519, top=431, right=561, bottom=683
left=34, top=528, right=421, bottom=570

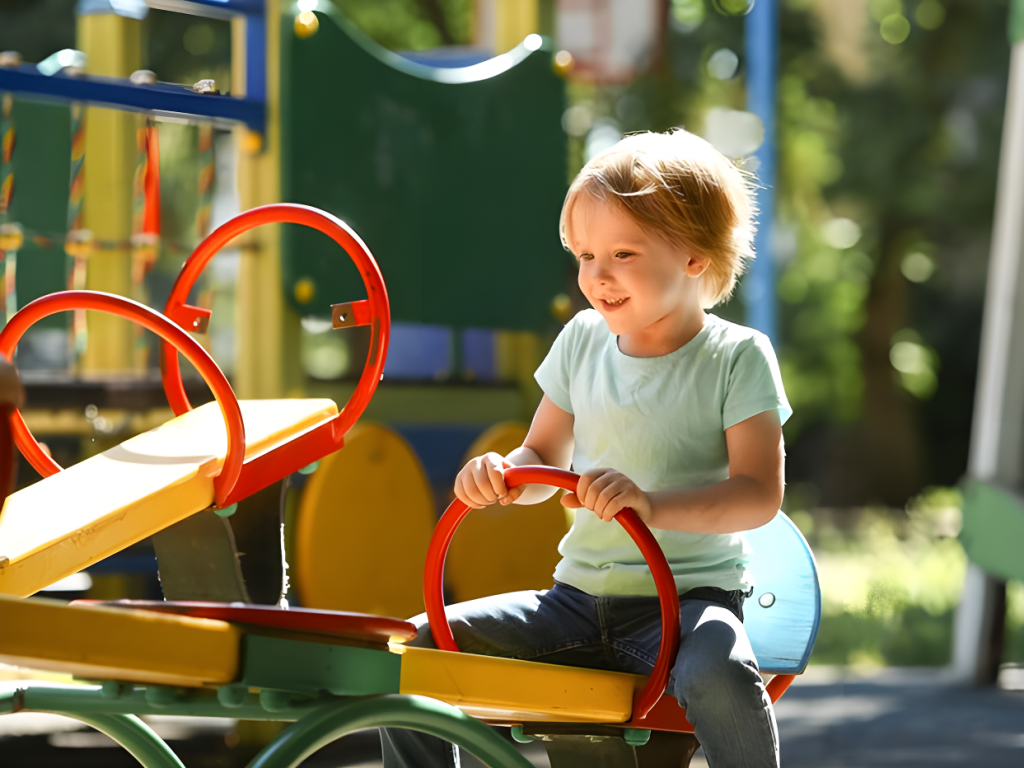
left=0, top=65, right=265, bottom=133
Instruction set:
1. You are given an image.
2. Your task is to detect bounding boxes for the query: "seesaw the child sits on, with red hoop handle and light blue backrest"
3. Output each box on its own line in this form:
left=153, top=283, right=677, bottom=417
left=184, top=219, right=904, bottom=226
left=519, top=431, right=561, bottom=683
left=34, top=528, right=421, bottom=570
left=0, top=467, right=818, bottom=768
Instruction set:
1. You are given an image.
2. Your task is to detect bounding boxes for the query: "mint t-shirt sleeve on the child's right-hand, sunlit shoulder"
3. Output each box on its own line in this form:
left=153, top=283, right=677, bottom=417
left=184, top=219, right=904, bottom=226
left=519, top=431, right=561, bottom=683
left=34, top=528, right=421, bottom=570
left=722, top=334, right=793, bottom=429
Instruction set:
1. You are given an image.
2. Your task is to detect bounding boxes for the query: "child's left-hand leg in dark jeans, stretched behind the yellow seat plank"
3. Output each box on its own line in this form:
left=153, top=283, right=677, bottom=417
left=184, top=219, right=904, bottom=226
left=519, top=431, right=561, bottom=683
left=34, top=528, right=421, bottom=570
left=381, top=585, right=606, bottom=768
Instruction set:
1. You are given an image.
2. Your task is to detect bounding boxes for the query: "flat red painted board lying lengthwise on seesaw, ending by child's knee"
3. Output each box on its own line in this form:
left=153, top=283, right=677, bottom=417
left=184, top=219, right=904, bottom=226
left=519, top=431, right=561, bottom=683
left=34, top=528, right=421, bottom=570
left=72, top=600, right=416, bottom=643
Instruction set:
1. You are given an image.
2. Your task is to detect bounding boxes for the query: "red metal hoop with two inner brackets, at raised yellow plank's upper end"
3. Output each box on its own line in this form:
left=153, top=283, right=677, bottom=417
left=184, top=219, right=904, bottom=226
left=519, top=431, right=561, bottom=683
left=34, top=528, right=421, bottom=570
left=160, top=203, right=391, bottom=440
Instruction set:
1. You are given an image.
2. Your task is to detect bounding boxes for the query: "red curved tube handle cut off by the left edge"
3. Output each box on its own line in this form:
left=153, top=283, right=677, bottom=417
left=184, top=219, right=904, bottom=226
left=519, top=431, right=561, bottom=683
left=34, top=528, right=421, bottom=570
left=0, top=291, right=246, bottom=506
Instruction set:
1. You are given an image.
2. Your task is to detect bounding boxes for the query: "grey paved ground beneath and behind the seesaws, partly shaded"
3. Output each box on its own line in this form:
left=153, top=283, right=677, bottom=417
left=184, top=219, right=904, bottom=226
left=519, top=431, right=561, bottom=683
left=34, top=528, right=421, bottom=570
left=0, top=668, right=1024, bottom=768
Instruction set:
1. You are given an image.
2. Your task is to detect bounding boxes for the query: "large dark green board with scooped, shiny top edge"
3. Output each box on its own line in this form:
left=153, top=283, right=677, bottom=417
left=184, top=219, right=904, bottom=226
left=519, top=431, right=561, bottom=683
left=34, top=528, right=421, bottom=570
left=282, top=6, right=571, bottom=330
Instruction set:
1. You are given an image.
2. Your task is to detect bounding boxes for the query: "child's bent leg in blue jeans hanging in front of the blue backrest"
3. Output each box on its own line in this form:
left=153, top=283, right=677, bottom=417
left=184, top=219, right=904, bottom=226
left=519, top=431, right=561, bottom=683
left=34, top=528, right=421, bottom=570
left=669, top=600, right=778, bottom=768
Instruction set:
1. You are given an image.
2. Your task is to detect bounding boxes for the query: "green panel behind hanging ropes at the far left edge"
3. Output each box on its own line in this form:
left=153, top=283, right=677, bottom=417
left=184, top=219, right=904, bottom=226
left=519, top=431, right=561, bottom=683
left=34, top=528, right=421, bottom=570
left=11, top=98, right=71, bottom=328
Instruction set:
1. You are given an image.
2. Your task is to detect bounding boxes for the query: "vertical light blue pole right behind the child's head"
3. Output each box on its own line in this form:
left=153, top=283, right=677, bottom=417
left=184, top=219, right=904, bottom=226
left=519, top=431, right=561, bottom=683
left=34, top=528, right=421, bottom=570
left=743, top=0, right=779, bottom=347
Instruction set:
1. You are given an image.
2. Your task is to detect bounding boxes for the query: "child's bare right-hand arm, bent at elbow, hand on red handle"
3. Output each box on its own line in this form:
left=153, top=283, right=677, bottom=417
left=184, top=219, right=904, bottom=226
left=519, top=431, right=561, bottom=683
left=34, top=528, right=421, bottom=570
left=562, top=411, right=785, bottom=534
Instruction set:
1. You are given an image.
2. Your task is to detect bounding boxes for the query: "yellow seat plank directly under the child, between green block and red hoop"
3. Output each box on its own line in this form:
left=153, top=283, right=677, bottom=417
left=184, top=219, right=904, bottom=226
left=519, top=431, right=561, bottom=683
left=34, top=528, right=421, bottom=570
left=393, top=646, right=644, bottom=723
